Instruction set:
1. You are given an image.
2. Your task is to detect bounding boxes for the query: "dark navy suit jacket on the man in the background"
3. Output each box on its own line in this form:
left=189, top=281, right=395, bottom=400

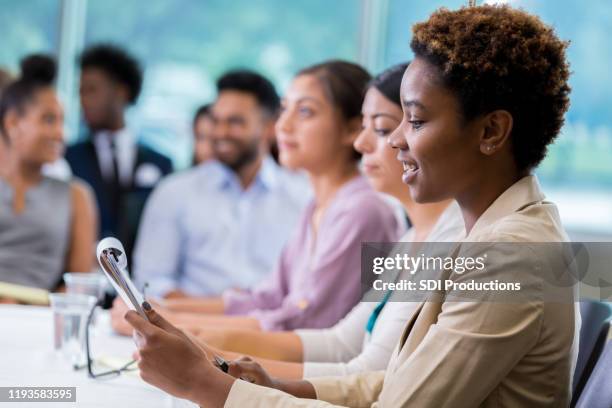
left=66, top=140, right=172, bottom=260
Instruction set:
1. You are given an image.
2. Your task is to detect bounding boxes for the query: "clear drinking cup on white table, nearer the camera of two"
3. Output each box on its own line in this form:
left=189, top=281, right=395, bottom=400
left=49, top=293, right=97, bottom=366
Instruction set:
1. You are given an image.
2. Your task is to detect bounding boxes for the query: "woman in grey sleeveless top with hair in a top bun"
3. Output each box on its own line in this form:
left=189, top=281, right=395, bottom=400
left=0, top=55, right=97, bottom=300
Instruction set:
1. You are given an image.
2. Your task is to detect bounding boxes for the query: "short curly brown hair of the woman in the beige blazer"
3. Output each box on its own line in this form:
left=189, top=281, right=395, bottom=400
left=410, top=5, right=570, bottom=171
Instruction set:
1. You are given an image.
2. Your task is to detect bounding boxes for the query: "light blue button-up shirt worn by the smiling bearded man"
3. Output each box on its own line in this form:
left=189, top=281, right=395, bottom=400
left=134, top=158, right=311, bottom=296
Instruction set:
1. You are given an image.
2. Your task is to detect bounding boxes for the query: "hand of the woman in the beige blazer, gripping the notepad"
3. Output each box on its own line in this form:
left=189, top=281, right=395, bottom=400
left=125, top=302, right=233, bottom=406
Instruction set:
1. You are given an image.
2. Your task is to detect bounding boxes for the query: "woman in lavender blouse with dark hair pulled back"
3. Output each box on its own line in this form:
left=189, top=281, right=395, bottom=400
left=113, top=61, right=400, bottom=333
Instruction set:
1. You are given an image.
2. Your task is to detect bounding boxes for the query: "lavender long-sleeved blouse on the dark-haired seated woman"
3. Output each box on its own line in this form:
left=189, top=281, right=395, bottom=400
left=223, top=175, right=398, bottom=330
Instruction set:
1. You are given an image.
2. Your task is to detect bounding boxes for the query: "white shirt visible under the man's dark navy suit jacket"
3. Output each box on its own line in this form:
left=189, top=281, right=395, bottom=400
left=93, top=127, right=136, bottom=186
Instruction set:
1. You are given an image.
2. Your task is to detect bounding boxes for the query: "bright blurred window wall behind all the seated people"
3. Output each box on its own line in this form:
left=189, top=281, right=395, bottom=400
left=0, top=0, right=612, bottom=233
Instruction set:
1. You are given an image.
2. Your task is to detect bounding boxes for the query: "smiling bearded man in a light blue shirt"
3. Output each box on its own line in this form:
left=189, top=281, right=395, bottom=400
left=134, top=71, right=310, bottom=297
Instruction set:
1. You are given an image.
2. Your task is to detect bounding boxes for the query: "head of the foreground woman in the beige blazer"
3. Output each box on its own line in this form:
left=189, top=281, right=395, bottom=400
left=395, top=3, right=570, bottom=231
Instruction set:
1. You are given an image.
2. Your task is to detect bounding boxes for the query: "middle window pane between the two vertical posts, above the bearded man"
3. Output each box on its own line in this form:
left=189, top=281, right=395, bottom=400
left=85, top=0, right=360, bottom=167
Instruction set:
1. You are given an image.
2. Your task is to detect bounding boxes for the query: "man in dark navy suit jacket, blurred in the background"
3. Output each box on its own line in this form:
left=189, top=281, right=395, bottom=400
left=66, top=44, right=172, bottom=259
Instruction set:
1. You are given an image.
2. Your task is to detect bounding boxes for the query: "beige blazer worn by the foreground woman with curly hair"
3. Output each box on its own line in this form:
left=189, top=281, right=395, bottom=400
left=225, top=176, right=576, bottom=408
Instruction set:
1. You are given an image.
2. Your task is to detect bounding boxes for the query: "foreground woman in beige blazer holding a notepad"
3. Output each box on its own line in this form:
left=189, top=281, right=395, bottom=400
left=122, top=6, right=578, bottom=408
